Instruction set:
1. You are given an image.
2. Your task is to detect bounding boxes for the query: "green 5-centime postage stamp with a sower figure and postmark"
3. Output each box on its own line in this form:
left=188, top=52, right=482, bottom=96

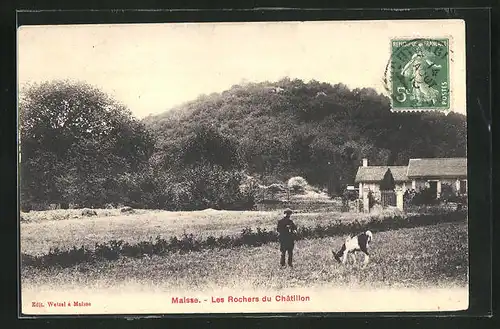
left=389, top=38, right=450, bottom=113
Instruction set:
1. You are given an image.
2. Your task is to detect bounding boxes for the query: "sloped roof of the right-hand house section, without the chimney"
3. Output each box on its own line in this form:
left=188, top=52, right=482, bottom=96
left=407, top=158, right=467, bottom=178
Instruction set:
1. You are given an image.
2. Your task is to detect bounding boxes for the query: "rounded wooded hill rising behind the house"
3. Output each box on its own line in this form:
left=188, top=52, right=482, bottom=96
left=143, top=78, right=467, bottom=193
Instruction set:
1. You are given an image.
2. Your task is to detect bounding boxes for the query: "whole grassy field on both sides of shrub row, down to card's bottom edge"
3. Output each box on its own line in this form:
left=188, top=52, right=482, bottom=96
left=21, top=210, right=468, bottom=314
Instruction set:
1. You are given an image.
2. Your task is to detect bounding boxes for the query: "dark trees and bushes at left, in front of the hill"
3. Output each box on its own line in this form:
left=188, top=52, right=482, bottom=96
left=20, top=81, right=255, bottom=210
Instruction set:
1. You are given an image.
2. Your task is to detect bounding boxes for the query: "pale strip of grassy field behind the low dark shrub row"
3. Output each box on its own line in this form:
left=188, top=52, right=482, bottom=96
left=21, top=209, right=404, bottom=255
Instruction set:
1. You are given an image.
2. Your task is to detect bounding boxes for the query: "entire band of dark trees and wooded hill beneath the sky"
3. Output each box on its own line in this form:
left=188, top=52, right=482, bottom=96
left=19, top=78, right=466, bottom=210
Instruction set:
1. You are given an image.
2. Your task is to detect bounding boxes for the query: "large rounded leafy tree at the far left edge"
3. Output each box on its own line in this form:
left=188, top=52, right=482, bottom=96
left=19, top=80, right=153, bottom=206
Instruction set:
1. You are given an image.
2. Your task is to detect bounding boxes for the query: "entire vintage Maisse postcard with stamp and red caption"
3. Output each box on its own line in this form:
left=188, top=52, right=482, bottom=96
left=18, top=19, right=469, bottom=317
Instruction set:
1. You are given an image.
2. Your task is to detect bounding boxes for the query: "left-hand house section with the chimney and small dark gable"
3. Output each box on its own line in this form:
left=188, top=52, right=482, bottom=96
left=355, top=159, right=411, bottom=199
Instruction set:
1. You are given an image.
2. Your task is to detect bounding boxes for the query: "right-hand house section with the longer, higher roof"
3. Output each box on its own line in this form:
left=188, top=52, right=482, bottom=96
left=407, top=158, right=467, bottom=198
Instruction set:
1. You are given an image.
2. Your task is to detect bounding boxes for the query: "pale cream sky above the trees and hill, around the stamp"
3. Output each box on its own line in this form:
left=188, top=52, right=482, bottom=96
left=18, top=20, right=466, bottom=118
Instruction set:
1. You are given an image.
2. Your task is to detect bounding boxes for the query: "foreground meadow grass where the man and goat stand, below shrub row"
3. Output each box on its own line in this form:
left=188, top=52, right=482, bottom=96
left=21, top=222, right=468, bottom=291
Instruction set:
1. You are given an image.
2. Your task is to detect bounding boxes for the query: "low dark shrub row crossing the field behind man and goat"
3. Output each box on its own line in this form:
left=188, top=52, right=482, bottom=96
left=21, top=211, right=467, bottom=267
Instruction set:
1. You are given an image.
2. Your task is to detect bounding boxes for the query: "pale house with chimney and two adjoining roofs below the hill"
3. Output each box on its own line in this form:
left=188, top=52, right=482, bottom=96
left=355, top=158, right=467, bottom=199
